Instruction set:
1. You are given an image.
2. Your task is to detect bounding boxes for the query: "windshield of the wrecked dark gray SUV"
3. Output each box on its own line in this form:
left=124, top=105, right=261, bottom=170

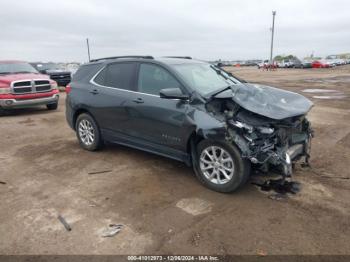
left=174, top=63, right=240, bottom=95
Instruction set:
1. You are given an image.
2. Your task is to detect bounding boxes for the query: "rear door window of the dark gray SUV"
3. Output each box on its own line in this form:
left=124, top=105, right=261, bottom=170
left=95, top=63, right=136, bottom=90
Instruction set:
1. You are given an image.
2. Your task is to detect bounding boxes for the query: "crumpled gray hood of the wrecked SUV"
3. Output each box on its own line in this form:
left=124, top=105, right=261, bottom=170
left=215, top=83, right=313, bottom=120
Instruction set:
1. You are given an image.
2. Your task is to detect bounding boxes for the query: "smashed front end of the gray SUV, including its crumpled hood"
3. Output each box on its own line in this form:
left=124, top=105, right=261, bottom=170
left=202, top=83, right=313, bottom=181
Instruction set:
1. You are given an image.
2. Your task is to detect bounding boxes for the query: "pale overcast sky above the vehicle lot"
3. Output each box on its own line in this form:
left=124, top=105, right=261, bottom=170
left=0, top=0, right=350, bottom=62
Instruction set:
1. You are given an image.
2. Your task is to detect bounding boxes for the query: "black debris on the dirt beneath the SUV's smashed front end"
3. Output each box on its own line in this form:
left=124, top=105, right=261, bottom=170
left=252, top=179, right=300, bottom=194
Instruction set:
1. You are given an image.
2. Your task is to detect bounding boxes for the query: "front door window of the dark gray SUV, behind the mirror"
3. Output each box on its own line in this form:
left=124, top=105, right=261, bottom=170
left=138, top=64, right=181, bottom=95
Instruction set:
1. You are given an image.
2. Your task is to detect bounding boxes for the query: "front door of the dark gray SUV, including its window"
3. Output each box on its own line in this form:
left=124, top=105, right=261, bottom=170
left=130, top=63, right=190, bottom=154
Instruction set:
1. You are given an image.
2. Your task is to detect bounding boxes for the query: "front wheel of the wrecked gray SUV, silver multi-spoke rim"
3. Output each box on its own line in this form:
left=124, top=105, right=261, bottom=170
left=194, top=140, right=250, bottom=193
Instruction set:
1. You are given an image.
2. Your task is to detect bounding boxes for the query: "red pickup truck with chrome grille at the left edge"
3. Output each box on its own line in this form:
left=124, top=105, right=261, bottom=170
left=0, top=61, right=59, bottom=115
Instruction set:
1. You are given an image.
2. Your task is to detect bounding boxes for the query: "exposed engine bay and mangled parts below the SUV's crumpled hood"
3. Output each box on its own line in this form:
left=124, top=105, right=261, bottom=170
left=206, top=98, right=313, bottom=178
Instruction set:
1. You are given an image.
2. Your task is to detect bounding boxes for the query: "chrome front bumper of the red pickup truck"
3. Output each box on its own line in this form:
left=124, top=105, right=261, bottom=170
left=0, top=93, right=59, bottom=109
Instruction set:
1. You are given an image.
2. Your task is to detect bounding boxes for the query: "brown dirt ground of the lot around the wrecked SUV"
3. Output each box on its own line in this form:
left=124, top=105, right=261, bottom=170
left=0, top=66, right=350, bottom=255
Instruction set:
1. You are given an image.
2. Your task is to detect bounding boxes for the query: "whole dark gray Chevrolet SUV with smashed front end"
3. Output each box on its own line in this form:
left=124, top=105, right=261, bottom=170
left=66, top=56, right=312, bottom=192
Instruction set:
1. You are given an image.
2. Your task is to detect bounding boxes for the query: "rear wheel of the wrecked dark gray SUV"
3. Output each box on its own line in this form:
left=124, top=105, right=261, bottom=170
left=75, top=113, right=103, bottom=151
